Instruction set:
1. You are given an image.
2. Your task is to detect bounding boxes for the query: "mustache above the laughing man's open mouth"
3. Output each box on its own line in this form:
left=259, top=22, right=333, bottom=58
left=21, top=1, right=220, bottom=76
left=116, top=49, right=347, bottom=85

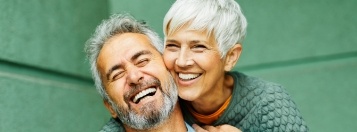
left=124, top=78, right=161, bottom=102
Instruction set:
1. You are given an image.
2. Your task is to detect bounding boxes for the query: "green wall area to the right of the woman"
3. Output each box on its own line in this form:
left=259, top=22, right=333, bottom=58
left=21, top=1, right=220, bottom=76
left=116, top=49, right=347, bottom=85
left=236, top=0, right=357, bottom=132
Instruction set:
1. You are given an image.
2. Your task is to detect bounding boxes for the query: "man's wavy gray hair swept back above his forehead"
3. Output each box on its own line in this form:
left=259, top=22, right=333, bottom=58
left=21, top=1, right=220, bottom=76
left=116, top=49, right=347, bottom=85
left=85, top=14, right=164, bottom=101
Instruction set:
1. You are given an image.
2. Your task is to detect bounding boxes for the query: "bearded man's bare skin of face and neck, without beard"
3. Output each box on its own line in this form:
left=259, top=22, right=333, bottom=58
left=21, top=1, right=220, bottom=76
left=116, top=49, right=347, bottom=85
left=97, top=33, right=186, bottom=131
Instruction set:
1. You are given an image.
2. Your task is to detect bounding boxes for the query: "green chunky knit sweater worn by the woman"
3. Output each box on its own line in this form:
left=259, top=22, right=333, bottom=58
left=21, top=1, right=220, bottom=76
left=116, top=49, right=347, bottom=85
left=180, top=72, right=308, bottom=132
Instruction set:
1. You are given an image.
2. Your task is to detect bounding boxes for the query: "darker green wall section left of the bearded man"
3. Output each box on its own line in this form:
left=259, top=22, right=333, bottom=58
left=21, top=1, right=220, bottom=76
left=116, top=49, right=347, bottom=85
left=0, top=0, right=109, bottom=132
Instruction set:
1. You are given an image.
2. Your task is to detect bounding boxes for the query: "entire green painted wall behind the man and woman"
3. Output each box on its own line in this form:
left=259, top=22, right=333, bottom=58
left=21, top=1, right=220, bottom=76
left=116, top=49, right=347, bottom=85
left=0, top=0, right=357, bottom=132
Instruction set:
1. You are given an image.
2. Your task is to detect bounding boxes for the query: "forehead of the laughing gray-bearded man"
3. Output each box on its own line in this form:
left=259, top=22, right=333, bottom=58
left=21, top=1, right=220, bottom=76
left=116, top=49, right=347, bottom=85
left=97, top=33, right=158, bottom=69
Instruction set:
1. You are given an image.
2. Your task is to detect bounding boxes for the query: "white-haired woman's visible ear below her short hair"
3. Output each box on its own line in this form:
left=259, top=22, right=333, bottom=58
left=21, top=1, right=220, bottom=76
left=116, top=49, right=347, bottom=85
left=224, top=44, right=242, bottom=71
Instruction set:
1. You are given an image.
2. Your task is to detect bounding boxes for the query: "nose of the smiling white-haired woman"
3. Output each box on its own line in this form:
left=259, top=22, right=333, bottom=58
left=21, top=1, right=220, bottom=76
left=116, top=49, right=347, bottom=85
left=175, top=49, right=194, bottom=67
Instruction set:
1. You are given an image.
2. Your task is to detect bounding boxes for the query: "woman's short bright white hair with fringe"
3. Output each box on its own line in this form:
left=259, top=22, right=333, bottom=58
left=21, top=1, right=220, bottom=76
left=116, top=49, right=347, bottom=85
left=163, top=0, right=247, bottom=58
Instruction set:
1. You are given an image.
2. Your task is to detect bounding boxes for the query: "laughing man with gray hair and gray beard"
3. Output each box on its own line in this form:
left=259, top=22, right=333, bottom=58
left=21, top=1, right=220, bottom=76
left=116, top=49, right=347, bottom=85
left=86, top=14, right=193, bottom=132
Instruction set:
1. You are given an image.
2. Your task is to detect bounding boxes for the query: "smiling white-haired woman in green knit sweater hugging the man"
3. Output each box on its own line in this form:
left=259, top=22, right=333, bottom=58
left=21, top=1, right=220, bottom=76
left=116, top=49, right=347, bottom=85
left=163, top=0, right=308, bottom=131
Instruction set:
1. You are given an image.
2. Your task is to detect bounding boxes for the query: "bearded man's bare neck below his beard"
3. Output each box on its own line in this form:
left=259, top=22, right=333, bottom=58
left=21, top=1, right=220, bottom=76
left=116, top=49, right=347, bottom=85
left=124, top=103, right=187, bottom=132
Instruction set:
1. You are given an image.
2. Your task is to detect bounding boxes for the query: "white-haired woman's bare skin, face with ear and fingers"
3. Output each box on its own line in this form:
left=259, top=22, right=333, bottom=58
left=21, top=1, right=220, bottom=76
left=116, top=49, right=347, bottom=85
left=163, top=25, right=242, bottom=131
